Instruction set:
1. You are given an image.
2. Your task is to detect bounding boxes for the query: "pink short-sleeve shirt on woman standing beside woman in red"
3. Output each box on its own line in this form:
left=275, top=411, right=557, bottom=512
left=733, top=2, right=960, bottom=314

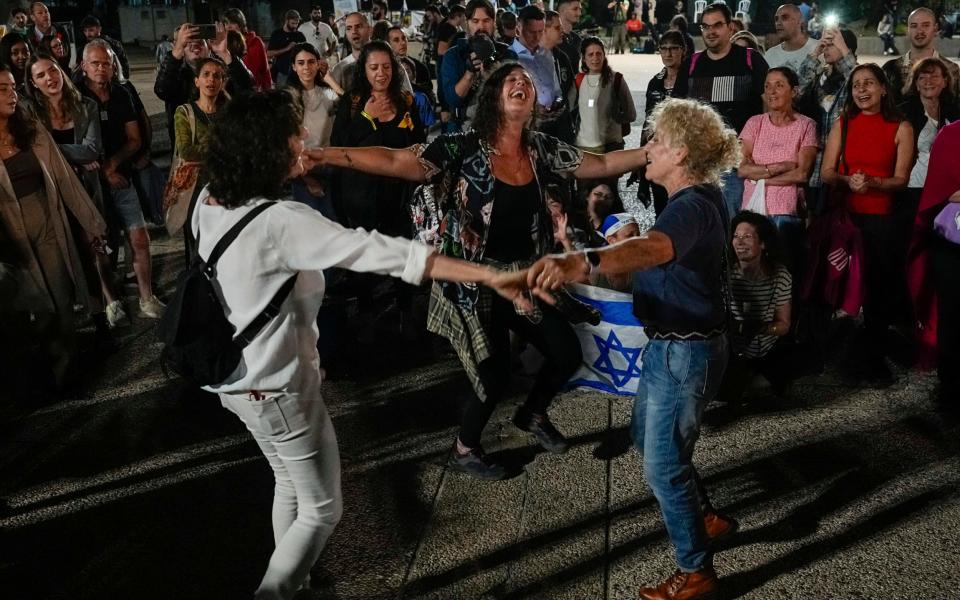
left=740, top=113, right=819, bottom=215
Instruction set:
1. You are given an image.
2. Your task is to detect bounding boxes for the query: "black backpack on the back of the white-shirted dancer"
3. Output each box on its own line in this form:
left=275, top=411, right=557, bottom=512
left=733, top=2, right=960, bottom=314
left=157, top=202, right=297, bottom=386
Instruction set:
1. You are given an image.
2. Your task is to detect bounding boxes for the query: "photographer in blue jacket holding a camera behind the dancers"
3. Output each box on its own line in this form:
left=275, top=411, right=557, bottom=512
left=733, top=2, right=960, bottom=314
left=439, top=0, right=517, bottom=133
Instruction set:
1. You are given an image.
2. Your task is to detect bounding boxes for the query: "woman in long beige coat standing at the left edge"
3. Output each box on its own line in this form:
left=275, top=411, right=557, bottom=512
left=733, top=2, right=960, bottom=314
left=0, top=66, right=106, bottom=389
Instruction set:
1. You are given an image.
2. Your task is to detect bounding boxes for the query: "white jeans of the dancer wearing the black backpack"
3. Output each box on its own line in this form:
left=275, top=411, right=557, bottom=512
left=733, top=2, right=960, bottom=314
left=220, top=373, right=343, bottom=600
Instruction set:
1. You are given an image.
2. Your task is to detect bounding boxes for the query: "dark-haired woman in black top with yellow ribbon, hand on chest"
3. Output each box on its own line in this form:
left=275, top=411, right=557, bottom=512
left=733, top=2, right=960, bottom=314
left=331, top=41, right=426, bottom=237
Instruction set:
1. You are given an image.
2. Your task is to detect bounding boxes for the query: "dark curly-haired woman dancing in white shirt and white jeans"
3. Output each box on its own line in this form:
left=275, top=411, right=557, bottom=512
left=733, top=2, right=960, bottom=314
left=191, top=90, right=529, bottom=599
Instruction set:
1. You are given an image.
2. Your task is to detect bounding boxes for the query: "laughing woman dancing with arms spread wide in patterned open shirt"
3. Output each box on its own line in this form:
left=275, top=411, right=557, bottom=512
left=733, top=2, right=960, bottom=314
left=308, top=63, right=646, bottom=479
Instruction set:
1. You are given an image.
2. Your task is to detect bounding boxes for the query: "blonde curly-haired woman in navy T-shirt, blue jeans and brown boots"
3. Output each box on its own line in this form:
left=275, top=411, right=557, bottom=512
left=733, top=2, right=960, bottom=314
left=528, top=98, right=740, bottom=599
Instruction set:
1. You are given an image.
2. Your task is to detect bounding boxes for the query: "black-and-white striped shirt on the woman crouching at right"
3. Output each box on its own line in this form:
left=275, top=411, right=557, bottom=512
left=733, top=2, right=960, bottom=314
left=730, top=265, right=793, bottom=358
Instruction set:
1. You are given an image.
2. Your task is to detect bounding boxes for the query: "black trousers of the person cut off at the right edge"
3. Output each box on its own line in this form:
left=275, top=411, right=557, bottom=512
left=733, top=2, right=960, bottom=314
left=930, top=239, right=960, bottom=397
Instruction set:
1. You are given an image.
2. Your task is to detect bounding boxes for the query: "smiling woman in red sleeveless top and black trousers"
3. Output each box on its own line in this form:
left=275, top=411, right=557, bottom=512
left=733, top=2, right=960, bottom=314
left=820, top=63, right=916, bottom=385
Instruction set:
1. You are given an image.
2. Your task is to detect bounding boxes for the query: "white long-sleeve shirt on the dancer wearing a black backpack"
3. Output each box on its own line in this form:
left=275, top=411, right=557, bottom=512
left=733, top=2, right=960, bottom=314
left=191, top=189, right=433, bottom=393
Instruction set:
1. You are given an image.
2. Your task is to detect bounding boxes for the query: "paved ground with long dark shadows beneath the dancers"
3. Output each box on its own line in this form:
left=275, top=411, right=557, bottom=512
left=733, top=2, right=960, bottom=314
left=0, top=48, right=960, bottom=600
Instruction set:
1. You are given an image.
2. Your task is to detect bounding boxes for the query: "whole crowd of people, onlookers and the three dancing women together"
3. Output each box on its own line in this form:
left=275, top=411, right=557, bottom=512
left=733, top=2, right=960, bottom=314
left=0, top=0, right=960, bottom=599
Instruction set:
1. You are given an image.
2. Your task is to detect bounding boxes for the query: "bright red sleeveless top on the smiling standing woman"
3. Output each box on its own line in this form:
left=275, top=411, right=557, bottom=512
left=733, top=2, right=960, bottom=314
left=838, top=113, right=900, bottom=215
